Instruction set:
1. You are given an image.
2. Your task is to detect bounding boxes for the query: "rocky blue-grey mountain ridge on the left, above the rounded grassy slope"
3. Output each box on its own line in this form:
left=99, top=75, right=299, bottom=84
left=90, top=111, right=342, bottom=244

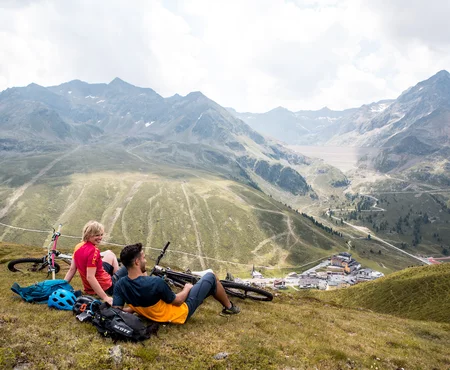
left=0, top=78, right=345, bottom=196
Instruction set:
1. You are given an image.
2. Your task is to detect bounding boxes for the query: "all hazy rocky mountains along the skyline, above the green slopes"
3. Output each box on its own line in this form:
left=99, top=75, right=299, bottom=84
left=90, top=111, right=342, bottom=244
left=0, top=71, right=450, bottom=198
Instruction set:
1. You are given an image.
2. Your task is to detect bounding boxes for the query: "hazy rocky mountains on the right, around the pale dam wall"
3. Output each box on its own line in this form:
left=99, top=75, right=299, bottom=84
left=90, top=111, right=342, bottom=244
left=236, top=70, right=450, bottom=185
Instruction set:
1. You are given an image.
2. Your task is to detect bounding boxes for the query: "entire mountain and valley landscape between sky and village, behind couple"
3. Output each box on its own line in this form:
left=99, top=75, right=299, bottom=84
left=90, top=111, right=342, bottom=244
left=0, top=71, right=450, bottom=274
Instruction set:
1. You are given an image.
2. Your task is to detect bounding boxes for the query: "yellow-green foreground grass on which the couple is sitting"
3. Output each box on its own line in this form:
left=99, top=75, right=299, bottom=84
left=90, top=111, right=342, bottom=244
left=0, top=243, right=450, bottom=369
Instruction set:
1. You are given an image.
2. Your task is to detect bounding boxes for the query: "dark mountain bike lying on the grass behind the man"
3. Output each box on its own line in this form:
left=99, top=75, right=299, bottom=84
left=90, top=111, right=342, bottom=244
left=149, top=242, right=273, bottom=301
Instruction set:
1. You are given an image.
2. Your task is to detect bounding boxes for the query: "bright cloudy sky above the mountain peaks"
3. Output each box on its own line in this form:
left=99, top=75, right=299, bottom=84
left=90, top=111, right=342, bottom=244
left=0, top=0, right=450, bottom=112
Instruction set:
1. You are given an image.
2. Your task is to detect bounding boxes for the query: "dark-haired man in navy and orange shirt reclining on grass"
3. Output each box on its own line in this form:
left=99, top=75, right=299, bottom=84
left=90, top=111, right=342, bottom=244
left=113, top=243, right=240, bottom=324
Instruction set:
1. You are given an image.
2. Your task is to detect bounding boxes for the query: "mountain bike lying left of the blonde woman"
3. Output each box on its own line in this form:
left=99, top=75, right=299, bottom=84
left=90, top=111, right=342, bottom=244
left=8, top=225, right=72, bottom=279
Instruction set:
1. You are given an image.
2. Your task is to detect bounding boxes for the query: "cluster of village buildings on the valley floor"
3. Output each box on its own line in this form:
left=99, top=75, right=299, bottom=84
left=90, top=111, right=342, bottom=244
left=242, top=252, right=384, bottom=290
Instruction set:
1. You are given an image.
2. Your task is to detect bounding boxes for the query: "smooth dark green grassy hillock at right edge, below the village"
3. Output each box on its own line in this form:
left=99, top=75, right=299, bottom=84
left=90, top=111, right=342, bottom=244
left=302, top=263, right=450, bottom=323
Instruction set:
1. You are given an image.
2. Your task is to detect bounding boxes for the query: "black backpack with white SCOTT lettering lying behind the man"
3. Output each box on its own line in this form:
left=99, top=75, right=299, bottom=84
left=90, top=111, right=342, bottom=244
left=92, top=303, right=159, bottom=342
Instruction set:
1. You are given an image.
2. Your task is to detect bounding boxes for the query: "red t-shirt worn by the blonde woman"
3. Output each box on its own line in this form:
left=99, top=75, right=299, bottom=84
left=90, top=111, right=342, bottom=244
left=73, top=242, right=112, bottom=294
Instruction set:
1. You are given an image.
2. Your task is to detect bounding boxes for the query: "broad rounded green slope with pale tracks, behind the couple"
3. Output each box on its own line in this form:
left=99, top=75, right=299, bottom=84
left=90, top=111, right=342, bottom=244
left=0, top=147, right=352, bottom=271
